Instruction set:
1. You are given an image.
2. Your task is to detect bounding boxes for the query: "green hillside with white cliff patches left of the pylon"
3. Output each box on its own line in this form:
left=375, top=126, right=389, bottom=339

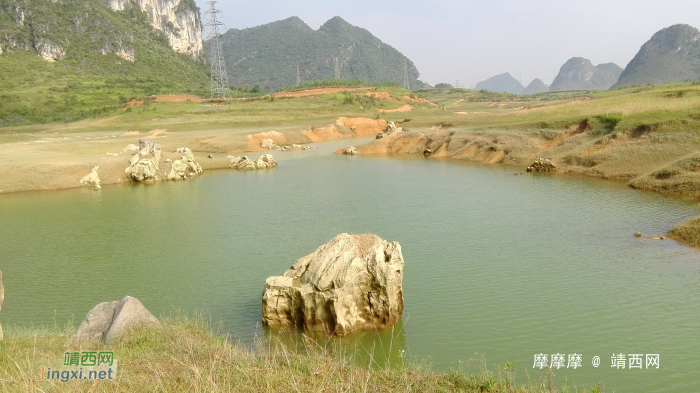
left=0, top=0, right=209, bottom=126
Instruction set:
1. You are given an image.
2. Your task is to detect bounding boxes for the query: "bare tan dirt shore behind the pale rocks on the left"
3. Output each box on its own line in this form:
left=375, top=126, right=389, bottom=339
left=0, top=117, right=387, bottom=193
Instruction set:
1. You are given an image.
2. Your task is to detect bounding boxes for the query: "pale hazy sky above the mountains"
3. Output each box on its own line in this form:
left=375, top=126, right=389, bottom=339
left=196, top=0, right=700, bottom=87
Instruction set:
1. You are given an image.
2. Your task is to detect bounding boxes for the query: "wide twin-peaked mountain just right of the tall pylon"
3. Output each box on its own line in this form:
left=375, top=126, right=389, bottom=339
left=213, top=16, right=428, bottom=89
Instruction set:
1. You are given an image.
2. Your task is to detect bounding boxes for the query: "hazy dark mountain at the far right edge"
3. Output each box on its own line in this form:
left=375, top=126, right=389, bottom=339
left=612, top=24, right=700, bottom=89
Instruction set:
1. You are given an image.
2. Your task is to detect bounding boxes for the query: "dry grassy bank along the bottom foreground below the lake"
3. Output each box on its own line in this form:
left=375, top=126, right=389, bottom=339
left=0, top=318, right=601, bottom=393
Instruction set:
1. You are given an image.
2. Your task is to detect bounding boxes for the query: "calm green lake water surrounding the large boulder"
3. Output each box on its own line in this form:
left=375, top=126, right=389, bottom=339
left=0, top=141, right=700, bottom=392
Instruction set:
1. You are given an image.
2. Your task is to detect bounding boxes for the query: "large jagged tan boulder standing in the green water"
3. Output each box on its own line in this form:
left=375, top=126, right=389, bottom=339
left=262, top=233, right=404, bottom=336
